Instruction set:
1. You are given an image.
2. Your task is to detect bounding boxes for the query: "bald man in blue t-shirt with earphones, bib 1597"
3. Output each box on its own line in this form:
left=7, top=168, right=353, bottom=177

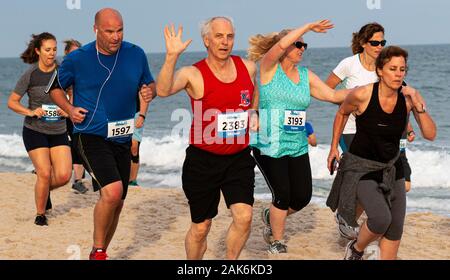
left=46, top=8, right=156, bottom=260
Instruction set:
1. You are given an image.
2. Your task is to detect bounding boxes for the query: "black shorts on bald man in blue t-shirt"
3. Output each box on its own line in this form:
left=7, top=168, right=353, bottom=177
left=73, top=133, right=131, bottom=199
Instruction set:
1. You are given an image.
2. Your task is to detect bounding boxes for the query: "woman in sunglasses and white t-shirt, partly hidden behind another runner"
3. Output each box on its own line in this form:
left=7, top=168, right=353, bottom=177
left=326, top=22, right=386, bottom=239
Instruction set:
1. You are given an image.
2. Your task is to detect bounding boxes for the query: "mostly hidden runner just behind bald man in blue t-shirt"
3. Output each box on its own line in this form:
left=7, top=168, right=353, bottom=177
left=64, top=39, right=88, bottom=193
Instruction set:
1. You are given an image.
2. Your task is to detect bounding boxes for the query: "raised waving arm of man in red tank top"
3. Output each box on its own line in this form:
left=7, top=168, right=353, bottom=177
left=156, top=25, right=192, bottom=97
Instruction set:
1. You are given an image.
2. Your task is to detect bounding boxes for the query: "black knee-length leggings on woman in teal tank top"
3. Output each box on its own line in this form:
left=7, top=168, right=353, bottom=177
left=253, top=148, right=312, bottom=211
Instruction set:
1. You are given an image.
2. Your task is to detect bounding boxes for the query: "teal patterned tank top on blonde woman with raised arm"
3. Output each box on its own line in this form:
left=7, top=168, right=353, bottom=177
left=251, top=64, right=311, bottom=158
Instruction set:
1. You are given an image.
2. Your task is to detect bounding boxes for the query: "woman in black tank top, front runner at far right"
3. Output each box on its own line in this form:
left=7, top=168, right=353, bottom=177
left=327, top=46, right=436, bottom=259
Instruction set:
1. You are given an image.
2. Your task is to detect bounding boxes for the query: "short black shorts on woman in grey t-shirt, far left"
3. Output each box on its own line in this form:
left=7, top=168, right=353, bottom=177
left=22, top=126, right=69, bottom=152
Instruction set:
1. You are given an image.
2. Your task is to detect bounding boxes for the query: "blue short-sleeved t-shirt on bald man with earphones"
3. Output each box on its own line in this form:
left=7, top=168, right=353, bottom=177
left=58, top=41, right=154, bottom=143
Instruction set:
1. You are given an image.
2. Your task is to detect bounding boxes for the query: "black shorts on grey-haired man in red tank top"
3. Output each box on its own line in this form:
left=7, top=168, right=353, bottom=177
left=182, top=146, right=255, bottom=223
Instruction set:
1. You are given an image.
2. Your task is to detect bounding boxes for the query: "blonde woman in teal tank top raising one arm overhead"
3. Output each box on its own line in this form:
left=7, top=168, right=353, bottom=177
left=248, top=20, right=348, bottom=253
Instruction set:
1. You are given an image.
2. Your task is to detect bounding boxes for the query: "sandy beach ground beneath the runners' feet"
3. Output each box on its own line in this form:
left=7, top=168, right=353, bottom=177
left=0, top=173, right=450, bottom=260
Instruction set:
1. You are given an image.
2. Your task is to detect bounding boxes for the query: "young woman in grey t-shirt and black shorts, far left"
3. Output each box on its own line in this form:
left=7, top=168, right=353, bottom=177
left=8, top=32, right=72, bottom=226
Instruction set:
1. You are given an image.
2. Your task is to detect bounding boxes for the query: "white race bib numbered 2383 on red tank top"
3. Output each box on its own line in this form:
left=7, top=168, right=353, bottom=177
left=217, top=112, right=248, bottom=138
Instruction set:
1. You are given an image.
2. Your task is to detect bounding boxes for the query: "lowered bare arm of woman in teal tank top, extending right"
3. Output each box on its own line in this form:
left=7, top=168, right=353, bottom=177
left=308, top=70, right=350, bottom=104
